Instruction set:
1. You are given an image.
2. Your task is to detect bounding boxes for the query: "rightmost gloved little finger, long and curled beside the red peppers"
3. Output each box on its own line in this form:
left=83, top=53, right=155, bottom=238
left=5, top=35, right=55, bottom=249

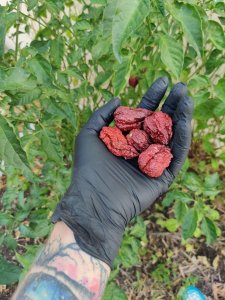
left=169, top=96, right=194, bottom=176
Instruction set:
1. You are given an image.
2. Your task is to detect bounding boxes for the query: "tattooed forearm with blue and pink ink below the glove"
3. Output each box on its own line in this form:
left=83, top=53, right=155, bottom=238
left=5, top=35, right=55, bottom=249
left=13, top=223, right=109, bottom=300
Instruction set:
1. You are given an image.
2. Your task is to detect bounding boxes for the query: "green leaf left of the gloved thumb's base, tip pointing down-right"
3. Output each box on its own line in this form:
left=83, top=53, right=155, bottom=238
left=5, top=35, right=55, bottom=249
left=40, top=127, right=63, bottom=163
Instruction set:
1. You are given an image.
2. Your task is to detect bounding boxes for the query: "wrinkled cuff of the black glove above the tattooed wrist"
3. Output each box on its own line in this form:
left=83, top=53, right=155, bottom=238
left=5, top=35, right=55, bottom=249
left=51, top=198, right=123, bottom=268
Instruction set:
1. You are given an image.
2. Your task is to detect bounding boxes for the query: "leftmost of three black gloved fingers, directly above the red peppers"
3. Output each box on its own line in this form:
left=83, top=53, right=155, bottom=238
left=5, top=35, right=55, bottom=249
left=138, top=77, right=169, bottom=110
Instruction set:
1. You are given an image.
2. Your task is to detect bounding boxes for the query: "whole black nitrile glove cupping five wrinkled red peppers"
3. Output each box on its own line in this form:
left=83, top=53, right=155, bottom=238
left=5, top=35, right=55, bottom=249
left=52, top=77, right=193, bottom=267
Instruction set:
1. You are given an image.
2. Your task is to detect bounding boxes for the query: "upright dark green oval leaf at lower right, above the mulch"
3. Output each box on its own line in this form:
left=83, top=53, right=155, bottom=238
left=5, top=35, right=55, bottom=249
left=182, top=208, right=198, bottom=240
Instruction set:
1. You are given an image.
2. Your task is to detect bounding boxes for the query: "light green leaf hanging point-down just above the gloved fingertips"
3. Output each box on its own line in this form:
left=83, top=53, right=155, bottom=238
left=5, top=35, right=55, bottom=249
left=159, top=35, right=184, bottom=78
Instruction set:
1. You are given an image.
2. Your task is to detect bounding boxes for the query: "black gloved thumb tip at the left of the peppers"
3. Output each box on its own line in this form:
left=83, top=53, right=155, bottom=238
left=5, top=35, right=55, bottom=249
left=84, top=98, right=120, bottom=133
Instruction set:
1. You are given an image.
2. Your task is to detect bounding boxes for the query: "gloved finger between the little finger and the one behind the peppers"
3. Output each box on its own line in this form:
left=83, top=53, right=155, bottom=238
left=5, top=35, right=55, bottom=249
left=162, top=82, right=187, bottom=117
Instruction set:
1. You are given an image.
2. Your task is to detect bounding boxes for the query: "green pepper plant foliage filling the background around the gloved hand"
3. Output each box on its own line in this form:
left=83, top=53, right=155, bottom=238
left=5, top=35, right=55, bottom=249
left=0, top=0, right=225, bottom=299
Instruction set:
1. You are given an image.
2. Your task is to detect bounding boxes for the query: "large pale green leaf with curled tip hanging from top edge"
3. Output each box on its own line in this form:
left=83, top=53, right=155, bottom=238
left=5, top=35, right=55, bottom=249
left=112, top=0, right=150, bottom=62
